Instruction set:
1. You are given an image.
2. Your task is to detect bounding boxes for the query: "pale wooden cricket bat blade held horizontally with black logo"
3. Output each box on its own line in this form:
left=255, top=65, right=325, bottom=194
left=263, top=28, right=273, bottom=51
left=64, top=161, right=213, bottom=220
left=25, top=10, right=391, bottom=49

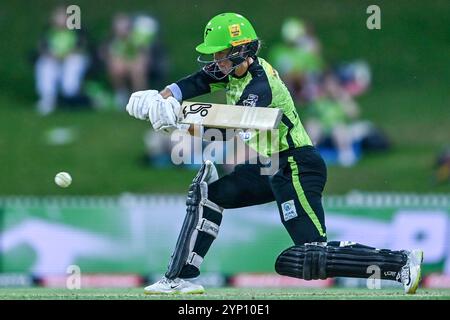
left=178, top=101, right=283, bottom=130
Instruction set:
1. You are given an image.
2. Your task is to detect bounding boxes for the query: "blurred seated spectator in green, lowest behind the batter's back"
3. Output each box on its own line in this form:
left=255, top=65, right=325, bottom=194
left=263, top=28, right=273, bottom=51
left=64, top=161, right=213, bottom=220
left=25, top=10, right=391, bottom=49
left=304, top=71, right=390, bottom=166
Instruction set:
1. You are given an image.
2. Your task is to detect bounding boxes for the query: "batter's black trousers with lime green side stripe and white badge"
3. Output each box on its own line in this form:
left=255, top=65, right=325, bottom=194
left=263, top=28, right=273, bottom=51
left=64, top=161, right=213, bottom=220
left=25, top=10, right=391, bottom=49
left=180, top=146, right=327, bottom=278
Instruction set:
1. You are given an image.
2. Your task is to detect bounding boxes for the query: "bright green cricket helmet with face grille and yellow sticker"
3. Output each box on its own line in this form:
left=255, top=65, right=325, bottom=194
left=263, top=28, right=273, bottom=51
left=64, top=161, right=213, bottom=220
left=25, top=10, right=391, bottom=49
left=196, top=13, right=260, bottom=79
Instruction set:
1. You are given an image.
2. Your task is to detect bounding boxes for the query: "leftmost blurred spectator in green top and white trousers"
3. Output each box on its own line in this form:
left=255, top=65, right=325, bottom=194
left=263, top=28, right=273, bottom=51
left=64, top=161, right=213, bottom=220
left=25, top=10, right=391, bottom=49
left=35, top=7, right=89, bottom=115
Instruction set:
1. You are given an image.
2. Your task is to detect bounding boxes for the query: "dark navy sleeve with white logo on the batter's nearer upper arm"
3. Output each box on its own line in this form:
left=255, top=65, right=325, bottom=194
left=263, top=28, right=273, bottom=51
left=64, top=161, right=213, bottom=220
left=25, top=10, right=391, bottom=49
left=236, top=62, right=272, bottom=107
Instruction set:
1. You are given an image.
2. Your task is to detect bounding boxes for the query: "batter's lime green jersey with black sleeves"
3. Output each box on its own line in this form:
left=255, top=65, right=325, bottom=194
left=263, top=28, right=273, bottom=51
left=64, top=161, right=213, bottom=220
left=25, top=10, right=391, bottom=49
left=176, top=58, right=312, bottom=156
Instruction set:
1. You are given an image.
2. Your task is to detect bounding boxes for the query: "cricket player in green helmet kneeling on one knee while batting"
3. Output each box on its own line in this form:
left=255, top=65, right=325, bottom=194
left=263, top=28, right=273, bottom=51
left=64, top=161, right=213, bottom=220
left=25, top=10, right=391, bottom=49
left=126, top=13, right=423, bottom=294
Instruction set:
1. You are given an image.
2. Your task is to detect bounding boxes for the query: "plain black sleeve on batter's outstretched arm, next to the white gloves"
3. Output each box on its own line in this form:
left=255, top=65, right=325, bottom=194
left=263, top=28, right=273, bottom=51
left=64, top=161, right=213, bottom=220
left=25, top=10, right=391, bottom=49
left=176, top=70, right=227, bottom=100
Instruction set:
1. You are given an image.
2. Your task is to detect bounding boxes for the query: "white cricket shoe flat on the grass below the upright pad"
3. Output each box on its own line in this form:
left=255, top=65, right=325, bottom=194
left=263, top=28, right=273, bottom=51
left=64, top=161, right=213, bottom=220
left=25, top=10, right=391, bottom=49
left=144, top=277, right=205, bottom=294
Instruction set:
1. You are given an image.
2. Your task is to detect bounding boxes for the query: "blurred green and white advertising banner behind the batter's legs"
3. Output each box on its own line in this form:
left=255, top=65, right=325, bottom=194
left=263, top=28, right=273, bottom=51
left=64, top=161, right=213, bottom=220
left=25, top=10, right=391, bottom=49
left=0, top=193, right=450, bottom=276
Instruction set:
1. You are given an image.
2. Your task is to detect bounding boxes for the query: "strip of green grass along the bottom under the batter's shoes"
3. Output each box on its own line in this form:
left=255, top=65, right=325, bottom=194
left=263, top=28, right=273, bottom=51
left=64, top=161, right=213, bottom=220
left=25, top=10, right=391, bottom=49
left=0, top=288, right=450, bottom=300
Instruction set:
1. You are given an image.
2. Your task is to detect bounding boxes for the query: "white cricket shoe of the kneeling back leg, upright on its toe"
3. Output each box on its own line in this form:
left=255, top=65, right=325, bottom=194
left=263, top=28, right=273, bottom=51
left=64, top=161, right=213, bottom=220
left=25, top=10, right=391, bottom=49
left=400, top=249, right=423, bottom=294
